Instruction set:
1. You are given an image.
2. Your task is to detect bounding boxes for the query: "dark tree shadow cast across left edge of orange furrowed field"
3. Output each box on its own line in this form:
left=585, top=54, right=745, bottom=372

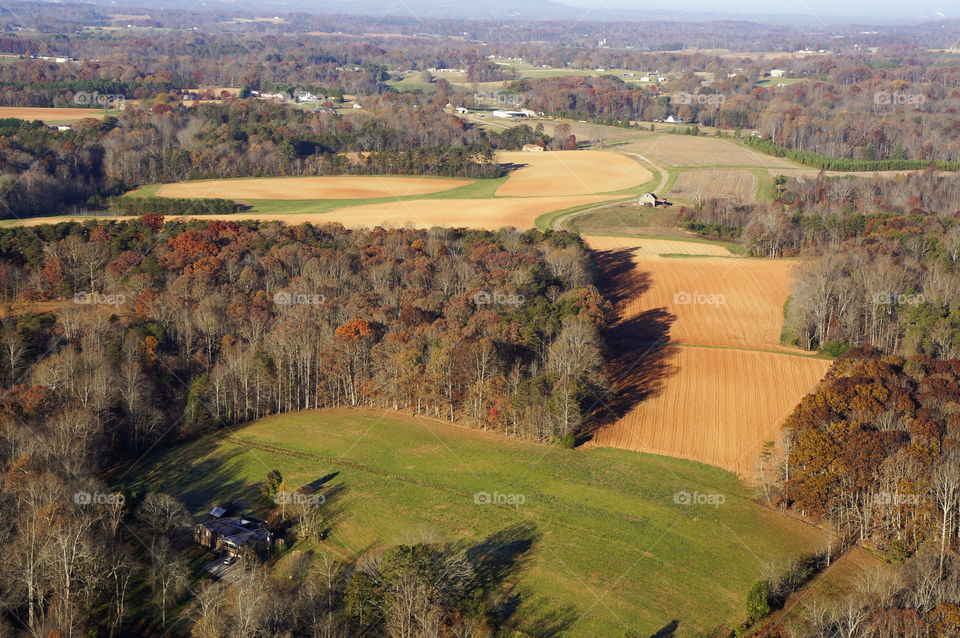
left=578, top=250, right=678, bottom=443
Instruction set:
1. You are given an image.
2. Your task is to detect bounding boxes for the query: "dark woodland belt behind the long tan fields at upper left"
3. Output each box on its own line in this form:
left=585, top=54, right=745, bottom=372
left=0, top=96, right=550, bottom=217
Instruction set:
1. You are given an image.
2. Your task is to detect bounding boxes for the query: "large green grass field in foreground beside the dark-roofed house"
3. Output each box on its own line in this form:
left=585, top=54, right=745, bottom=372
left=124, top=409, right=822, bottom=636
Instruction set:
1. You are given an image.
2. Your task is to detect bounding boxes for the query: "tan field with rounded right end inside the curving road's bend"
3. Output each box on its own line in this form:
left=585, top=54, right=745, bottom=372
left=497, top=151, right=653, bottom=197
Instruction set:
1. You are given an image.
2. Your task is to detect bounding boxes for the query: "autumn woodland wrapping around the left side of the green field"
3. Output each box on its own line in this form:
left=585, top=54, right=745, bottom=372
left=0, top=219, right=610, bottom=636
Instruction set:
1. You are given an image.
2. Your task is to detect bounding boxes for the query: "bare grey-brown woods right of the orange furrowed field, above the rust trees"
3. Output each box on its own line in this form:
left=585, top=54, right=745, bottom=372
left=681, top=169, right=960, bottom=359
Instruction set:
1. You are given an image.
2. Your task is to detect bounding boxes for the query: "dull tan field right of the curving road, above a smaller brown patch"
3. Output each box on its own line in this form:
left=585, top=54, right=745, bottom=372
left=618, top=135, right=797, bottom=168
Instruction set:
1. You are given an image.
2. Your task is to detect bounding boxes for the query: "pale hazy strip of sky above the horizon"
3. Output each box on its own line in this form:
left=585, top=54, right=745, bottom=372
left=558, top=0, right=960, bottom=21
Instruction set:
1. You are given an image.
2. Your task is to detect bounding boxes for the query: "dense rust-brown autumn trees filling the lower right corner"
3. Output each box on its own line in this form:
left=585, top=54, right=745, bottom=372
left=760, top=347, right=960, bottom=638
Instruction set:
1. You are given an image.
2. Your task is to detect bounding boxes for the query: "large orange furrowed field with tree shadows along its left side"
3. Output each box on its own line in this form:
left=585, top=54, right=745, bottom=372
left=587, top=237, right=830, bottom=476
